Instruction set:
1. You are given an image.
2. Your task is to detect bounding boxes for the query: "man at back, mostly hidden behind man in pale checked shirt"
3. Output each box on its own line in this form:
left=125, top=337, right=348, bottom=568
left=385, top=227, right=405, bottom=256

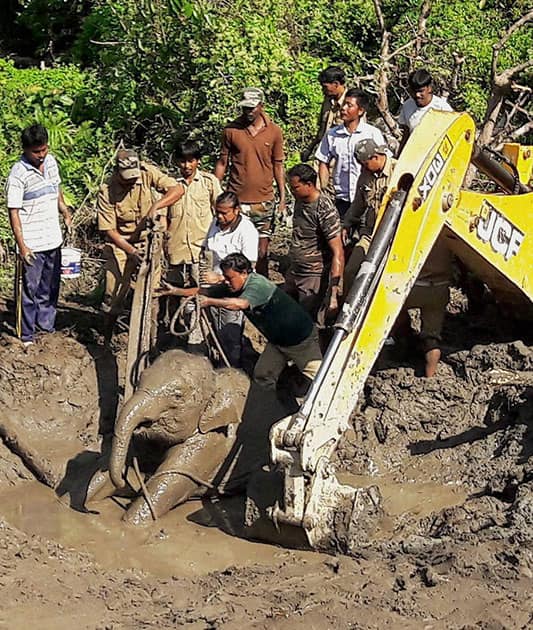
left=300, top=66, right=346, bottom=162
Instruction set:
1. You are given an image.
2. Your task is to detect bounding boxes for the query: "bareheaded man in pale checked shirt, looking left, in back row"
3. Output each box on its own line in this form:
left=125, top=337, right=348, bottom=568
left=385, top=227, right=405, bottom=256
left=315, top=88, right=385, bottom=218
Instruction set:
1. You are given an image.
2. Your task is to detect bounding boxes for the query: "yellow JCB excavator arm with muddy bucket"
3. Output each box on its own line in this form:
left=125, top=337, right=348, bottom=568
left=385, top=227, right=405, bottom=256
left=249, top=111, right=533, bottom=549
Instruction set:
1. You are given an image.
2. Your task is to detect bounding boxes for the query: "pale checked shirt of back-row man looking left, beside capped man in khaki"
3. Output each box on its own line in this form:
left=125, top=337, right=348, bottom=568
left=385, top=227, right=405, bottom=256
left=315, top=120, right=387, bottom=201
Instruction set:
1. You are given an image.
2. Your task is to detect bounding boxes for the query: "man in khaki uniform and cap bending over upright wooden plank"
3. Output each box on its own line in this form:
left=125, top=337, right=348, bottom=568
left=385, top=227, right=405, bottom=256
left=97, top=149, right=184, bottom=315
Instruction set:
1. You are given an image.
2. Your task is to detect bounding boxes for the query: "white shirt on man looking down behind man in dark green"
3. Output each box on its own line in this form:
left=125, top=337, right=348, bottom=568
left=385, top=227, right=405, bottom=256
left=204, top=214, right=259, bottom=273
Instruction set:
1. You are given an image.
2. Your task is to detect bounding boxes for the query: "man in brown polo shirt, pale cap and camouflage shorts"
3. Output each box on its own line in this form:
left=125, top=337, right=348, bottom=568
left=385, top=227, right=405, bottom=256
left=215, top=88, right=285, bottom=277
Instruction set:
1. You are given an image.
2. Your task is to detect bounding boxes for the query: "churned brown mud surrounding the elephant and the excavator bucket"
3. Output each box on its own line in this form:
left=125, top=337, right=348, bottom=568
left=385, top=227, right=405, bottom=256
left=0, top=304, right=533, bottom=629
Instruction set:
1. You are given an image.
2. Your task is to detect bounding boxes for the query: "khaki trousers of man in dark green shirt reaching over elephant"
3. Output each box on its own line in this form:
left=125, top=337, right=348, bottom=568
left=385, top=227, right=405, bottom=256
left=254, top=326, right=322, bottom=390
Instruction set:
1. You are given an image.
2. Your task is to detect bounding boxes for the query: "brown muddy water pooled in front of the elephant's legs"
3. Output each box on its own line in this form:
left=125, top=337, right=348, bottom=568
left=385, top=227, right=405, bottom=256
left=0, top=482, right=302, bottom=577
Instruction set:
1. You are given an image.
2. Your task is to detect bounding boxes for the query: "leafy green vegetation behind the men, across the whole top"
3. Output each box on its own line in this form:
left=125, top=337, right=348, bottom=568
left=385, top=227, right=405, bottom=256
left=0, top=0, right=531, bottom=262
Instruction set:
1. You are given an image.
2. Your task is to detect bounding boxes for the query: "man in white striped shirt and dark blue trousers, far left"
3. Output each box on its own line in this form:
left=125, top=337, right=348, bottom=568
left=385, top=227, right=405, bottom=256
left=6, top=124, right=72, bottom=345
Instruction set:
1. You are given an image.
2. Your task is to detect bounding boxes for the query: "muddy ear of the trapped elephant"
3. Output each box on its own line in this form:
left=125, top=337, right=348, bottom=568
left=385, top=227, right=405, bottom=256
left=198, top=368, right=250, bottom=433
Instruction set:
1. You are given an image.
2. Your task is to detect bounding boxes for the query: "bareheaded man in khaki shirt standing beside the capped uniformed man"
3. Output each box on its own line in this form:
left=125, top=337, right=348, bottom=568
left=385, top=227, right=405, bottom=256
left=167, top=142, right=222, bottom=287
